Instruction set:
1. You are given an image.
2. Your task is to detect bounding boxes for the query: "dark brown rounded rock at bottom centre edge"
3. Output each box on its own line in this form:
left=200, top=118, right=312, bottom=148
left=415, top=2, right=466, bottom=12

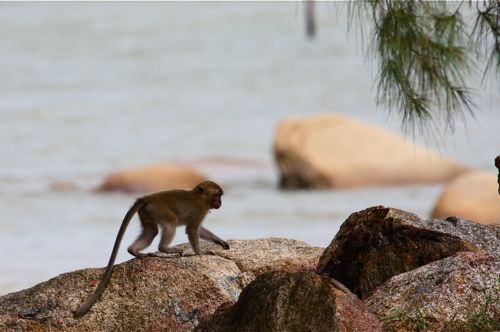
left=197, top=271, right=381, bottom=332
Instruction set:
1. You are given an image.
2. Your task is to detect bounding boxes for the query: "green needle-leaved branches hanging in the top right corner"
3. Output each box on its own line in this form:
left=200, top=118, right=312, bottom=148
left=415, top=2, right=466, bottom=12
left=348, top=0, right=500, bottom=129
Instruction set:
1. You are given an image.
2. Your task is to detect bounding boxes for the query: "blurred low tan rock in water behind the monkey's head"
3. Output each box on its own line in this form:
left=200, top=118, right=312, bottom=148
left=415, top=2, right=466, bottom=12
left=97, top=163, right=206, bottom=193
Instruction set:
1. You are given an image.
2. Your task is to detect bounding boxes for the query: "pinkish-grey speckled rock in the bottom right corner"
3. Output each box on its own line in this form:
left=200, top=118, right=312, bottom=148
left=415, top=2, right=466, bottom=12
left=364, top=252, right=500, bottom=331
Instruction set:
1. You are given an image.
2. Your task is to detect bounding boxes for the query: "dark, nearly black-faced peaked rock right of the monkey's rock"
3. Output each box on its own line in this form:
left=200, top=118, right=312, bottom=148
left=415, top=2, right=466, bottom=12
left=317, top=206, right=500, bottom=298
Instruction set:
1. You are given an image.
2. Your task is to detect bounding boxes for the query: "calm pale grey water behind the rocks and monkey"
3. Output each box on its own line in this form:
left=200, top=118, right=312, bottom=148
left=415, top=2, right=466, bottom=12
left=0, top=2, right=500, bottom=294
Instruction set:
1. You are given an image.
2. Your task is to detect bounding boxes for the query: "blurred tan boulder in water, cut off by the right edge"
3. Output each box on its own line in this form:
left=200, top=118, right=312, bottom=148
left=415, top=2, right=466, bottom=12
left=432, top=171, right=500, bottom=224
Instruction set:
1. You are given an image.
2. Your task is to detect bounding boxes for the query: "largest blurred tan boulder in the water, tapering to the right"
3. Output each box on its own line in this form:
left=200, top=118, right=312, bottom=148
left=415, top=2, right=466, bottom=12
left=274, top=114, right=468, bottom=188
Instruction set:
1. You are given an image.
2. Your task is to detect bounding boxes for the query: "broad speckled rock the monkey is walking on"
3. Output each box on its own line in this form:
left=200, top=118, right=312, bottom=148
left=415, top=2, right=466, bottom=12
left=0, top=238, right=322, bottom=331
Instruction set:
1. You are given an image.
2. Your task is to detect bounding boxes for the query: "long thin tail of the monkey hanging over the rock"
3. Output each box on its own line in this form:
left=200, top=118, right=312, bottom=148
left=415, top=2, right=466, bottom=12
left=73, top=199, right=144, bottom=317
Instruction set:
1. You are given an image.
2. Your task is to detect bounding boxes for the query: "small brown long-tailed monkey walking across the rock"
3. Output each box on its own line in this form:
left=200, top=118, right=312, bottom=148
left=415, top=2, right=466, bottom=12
left=73, top=181, right=229, bottom=317
